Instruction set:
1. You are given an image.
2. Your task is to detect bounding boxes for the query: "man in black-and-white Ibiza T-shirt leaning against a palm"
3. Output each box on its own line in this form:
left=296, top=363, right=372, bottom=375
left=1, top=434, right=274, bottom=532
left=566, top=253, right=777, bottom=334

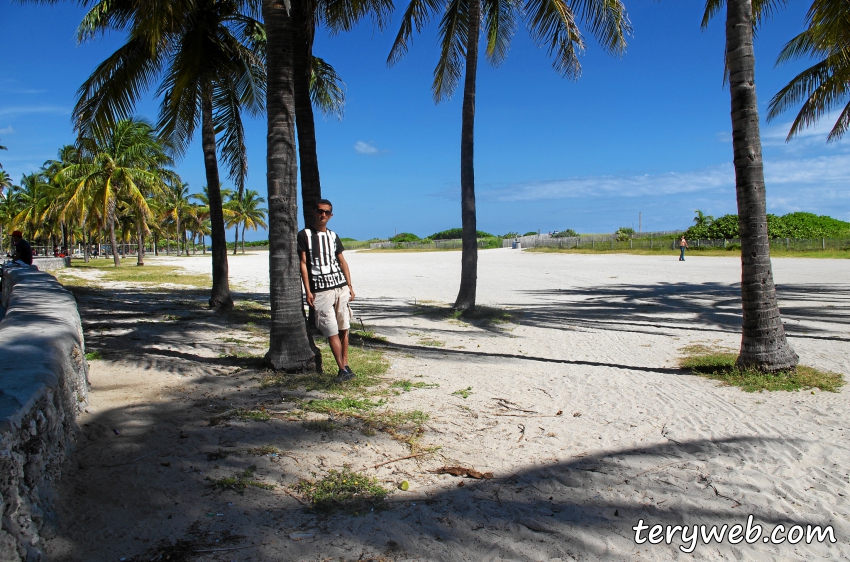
left=298, top=199, right=354, bottom=382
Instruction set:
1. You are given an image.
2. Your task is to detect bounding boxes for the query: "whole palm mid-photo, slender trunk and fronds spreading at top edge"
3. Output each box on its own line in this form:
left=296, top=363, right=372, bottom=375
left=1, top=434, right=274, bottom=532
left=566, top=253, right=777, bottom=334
left=387, top=0, right=631, bottom=310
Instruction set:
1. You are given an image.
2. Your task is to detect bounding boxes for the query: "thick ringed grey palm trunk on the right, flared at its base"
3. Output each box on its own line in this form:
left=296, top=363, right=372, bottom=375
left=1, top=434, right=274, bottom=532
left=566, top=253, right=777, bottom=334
left=726, top=0, right=798, bottom=372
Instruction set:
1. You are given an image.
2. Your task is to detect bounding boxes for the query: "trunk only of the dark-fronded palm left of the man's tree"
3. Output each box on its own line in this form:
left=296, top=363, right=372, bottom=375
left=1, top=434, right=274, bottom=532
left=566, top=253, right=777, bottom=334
left=201, top=90, right=233, bottom=309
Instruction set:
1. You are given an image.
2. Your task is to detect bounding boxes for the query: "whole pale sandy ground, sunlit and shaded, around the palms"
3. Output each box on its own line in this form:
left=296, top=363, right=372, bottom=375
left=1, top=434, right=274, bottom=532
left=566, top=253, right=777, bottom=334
left=47, top=249, right=850, bottom=561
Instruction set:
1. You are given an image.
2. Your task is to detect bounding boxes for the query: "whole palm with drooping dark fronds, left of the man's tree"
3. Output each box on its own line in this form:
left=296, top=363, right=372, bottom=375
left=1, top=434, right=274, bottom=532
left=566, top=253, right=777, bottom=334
left=60, top=0, right=265, bottom=309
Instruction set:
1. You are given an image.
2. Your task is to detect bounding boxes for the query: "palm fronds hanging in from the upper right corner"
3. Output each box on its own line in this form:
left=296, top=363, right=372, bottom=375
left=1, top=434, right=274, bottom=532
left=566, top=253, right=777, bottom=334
left=767, top=0, right=850, bottom=141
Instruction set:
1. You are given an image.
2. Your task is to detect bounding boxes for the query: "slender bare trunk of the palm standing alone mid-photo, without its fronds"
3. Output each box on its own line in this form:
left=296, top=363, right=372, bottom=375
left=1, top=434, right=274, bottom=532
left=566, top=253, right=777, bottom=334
left=454, top=0, right=481, bottom=310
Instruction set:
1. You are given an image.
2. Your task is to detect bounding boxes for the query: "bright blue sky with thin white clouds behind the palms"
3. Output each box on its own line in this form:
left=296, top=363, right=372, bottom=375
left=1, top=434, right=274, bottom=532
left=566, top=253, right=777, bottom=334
left=0, top=0, right=850, bottom=240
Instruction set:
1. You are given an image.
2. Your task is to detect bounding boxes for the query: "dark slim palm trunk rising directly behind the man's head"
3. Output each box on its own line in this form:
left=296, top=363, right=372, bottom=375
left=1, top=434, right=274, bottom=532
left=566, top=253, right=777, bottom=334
left=292, top=2, right=322, bottom=226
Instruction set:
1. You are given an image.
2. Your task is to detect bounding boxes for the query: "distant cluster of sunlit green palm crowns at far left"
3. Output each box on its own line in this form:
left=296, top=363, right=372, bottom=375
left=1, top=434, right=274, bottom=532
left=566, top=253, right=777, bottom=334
left=0, top=119, right=266, bottom=265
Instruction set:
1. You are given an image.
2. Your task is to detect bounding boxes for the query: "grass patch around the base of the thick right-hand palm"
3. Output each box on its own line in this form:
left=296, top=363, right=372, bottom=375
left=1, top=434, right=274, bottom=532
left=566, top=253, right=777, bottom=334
left=680, top=345, right=845, bottom=392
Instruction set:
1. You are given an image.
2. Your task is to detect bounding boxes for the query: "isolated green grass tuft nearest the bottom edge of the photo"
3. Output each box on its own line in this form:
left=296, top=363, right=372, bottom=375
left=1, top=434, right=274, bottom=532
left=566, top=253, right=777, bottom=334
left=293, top=465, right=390, bottom=515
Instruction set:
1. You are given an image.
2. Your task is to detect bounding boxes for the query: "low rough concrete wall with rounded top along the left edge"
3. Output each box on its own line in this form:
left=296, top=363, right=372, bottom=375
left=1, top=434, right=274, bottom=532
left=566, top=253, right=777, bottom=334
left=0, top=269, right=88, bottom=562
